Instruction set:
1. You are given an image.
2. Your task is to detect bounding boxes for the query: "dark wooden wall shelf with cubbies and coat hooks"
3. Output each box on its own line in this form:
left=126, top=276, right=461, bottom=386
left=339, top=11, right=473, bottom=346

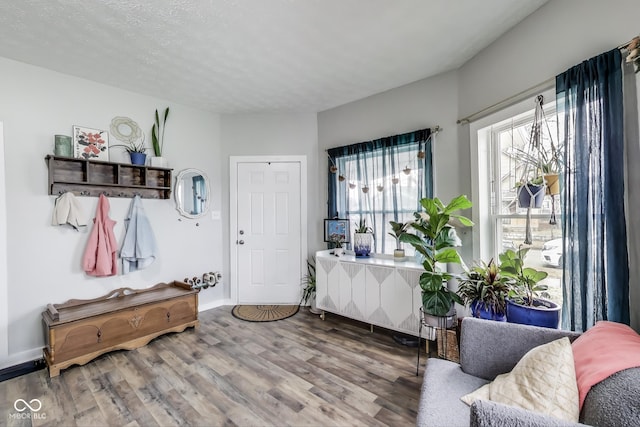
left=45, top=155, right=171, bottom=199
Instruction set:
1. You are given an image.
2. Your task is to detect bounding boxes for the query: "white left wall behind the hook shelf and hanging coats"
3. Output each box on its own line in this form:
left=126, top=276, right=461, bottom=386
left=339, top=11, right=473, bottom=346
left=0, top=59, right=224, bottom=368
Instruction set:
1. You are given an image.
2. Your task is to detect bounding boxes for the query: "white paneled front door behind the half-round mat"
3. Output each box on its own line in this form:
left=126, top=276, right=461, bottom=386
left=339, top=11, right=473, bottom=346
left=231, top=161, right=306, bottom=304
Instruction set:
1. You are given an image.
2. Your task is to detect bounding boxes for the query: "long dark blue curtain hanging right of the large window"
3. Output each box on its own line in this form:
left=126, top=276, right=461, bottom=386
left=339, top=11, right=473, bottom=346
left=556, top=49, right=629, bottom=331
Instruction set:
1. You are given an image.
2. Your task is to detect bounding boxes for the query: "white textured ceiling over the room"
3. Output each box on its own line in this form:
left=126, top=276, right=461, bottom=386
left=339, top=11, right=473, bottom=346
left=0, top=0, right=547, bottom=113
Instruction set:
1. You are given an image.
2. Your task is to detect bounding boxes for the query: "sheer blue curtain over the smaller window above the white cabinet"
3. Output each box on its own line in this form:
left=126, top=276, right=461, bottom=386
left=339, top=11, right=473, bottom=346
left=327, top=129, right=433, bottom=253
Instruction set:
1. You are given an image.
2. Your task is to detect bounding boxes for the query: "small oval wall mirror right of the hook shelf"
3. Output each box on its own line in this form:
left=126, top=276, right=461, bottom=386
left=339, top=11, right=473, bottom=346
left=173, top=169, right=209, bottom=218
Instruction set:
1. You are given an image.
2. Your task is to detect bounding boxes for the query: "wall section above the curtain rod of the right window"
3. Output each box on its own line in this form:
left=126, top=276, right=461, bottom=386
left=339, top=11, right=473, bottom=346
left=459, top=0, right=640, bottom=117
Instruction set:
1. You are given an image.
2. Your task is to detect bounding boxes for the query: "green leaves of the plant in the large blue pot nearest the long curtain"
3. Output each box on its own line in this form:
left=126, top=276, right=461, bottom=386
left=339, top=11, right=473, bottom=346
left=500, top=248, right=549, bottom=306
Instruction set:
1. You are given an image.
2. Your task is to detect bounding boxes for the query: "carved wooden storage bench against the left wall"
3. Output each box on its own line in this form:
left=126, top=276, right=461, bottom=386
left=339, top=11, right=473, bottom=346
left=42, top=282, right=198, bottom=377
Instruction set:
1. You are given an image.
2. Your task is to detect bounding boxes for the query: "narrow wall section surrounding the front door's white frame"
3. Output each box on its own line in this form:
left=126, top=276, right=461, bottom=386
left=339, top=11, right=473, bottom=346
left=220, top=113, right=326, bottom=298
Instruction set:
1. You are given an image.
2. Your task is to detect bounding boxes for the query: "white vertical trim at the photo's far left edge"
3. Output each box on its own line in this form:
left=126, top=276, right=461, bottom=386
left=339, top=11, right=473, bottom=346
left=0, top=122, right=9, bottom=365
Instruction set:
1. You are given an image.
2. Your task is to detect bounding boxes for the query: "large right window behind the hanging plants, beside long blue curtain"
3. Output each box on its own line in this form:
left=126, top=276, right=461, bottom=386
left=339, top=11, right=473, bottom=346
left=476, top=104, right=562, bottom=304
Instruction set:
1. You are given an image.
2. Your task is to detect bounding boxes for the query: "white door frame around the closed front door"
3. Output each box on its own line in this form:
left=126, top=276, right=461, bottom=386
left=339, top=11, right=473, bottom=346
left=229, top=156, right=308, bottom=304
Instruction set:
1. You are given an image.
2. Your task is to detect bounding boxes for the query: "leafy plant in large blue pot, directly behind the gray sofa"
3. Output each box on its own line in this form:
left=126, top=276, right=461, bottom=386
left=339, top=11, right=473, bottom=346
left=500, top=248, right=560, bottom=328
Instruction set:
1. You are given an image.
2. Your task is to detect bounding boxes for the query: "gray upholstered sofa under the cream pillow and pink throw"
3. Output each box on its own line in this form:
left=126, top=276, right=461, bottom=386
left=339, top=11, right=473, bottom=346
left=417, top=317, right=640, bottom=427
